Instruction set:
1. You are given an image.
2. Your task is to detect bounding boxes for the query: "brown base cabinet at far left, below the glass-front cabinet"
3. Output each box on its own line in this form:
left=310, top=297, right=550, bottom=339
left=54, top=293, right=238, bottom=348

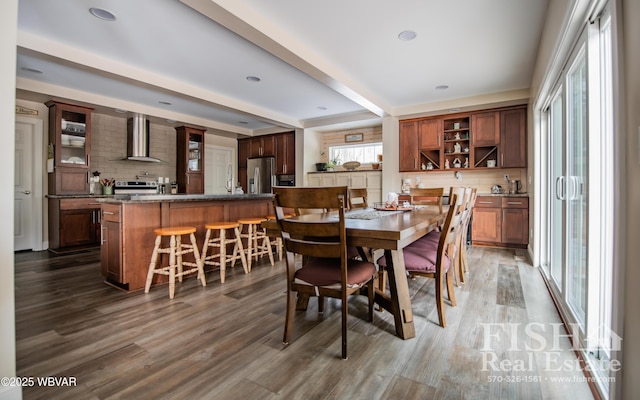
left=48, top=197, right=101, bottom=253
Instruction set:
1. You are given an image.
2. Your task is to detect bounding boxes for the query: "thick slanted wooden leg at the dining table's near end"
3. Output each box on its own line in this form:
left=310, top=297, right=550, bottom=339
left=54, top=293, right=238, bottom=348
left=376, top=249, right=416, bottom=339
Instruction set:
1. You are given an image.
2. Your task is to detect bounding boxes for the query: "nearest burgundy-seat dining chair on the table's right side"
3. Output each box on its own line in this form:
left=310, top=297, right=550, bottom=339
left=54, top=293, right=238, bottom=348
left=377, top=195, right=463, bottom=328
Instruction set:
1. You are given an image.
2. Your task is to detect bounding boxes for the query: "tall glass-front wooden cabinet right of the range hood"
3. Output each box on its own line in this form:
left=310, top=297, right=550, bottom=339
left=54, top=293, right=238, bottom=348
left=176, top=126, right=204, bottom=194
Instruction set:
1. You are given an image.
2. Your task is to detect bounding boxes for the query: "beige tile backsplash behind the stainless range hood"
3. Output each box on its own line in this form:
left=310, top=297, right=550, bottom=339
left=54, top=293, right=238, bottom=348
left=91, top=112, right=176, bottom=180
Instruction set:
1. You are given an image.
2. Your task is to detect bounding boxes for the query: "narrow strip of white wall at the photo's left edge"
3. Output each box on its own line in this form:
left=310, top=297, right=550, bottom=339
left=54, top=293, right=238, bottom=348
left=0, top=0, right=22, bottom=400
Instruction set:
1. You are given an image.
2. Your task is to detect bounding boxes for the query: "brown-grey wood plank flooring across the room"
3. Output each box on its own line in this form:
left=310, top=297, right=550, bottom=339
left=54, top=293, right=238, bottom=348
left=15, top=248, right=593, bottom=400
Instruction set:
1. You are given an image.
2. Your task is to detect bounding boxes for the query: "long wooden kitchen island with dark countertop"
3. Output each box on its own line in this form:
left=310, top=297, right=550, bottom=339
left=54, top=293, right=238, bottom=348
left=96, top=194, right=273, bottom=291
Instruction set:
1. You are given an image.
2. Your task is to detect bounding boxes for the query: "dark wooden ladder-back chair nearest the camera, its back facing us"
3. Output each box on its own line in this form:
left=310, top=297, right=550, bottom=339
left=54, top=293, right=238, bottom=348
left=273, top=186, right=376, bottom=359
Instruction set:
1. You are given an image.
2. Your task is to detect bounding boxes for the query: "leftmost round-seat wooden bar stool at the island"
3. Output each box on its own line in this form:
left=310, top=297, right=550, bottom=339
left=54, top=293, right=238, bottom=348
left=144, top=226, right=207, bottom=299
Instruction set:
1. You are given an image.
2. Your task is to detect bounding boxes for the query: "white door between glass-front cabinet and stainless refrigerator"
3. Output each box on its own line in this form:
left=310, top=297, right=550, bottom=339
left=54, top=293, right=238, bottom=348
left=204, top=143, right=238, bottom=194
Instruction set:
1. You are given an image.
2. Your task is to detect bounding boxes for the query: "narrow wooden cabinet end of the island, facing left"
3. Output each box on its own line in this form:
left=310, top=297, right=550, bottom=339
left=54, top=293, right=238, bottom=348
left=100, top=204, right=124, bottom=286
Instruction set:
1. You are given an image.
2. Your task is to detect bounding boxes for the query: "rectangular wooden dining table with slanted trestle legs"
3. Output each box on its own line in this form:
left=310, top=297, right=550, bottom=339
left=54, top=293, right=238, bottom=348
left=262, top=206, right=448, bottom=339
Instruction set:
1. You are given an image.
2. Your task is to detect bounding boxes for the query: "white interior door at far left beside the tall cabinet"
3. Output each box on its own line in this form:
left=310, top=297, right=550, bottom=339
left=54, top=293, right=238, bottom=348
left=13, top=120, right=35, bottom=251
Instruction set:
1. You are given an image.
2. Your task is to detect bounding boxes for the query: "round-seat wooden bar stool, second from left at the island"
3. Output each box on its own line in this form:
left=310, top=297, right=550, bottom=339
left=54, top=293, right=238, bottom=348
left=201, top=222, right=249, bottom=283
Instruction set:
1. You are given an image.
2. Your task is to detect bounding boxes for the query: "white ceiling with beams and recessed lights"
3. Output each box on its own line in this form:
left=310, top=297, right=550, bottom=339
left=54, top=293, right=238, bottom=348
left=17, top=0, right=548, bottom=135
